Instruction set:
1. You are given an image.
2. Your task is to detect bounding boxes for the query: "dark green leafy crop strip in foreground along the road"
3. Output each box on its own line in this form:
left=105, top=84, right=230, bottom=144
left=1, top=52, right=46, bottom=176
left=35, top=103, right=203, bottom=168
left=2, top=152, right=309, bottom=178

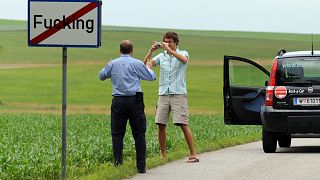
left=0, top=114, right=260, bottom=179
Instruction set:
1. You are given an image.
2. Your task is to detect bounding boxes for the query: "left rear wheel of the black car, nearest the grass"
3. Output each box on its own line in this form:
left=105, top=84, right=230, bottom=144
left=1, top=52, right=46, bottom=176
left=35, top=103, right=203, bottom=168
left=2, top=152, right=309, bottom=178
left=262, top=128, right=277, bottom=153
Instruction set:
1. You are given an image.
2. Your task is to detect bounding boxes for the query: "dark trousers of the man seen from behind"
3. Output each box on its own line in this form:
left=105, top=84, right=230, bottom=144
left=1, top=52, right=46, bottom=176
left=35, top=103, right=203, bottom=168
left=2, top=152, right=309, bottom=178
left=111, top=95, right=146, bottom=169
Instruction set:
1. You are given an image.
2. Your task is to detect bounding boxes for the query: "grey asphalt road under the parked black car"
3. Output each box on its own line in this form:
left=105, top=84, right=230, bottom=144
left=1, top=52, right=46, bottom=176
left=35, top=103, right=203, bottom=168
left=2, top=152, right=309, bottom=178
left=132, top=138, right=320, bottom=180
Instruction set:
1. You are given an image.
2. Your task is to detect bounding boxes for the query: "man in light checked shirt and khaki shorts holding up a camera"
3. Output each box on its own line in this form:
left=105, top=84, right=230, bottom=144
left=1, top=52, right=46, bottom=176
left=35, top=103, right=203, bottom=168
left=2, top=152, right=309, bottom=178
left=144, top=31, right=199, bottom=162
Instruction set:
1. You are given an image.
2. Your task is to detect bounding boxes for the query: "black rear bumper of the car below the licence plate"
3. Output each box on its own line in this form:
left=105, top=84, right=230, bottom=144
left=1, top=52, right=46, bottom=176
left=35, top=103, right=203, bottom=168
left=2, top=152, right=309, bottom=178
left=261, top=106, right=320, bottom=133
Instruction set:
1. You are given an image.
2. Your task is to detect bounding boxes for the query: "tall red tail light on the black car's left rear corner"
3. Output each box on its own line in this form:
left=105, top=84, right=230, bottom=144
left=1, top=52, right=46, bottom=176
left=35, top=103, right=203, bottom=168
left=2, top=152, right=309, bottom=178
left=264, top=59, right=278, bottom=106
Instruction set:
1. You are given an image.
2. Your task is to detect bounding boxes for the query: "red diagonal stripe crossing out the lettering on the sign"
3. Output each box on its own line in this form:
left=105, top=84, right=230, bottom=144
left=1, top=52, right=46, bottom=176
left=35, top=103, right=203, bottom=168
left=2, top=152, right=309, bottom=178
left=30, top=2, right=98, bottom=44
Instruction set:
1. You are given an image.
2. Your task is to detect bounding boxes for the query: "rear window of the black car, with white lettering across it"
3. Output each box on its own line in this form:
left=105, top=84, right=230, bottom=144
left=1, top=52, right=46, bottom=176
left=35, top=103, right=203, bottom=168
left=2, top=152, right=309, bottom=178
left=277, top=57, right=320, bottom=86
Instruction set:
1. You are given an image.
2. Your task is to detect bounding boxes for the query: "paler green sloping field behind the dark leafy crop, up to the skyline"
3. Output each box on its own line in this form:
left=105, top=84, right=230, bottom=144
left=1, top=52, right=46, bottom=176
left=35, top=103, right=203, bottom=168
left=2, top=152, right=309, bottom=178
left=0, top=20, right=320, bottom=114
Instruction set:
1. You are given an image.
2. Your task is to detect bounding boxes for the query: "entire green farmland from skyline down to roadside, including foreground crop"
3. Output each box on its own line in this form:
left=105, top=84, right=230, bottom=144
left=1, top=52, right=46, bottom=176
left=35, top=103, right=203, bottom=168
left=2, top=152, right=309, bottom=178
left=0, top=20, right=320, bottom=179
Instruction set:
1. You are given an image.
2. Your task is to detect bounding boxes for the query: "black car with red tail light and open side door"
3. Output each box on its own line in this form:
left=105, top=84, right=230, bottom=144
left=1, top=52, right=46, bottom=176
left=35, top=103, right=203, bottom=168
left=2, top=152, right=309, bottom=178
left=223, top=51, right=320, bottom=153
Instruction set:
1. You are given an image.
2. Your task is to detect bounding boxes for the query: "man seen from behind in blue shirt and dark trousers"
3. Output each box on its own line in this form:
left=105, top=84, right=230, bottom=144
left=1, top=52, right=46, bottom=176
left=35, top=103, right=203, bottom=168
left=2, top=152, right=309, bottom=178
left=99, top=40, right=156, bottom=173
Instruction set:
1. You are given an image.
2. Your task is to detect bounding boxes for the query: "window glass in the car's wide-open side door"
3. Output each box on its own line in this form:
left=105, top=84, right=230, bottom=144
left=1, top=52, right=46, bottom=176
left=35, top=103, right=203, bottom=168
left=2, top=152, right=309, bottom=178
left=229, top=60, right=269, bottom=87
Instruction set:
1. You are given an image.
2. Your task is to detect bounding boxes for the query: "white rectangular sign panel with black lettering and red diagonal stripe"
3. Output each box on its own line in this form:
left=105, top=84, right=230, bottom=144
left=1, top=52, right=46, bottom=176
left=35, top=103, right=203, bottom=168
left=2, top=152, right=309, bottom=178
left=28, top=0, right=101, bottom=47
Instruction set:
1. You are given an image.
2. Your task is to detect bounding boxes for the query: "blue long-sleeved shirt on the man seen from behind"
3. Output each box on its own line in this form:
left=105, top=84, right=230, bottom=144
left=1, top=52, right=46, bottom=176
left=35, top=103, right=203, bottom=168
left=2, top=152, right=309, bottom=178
left=98, top=54, right=156, bottom=96
